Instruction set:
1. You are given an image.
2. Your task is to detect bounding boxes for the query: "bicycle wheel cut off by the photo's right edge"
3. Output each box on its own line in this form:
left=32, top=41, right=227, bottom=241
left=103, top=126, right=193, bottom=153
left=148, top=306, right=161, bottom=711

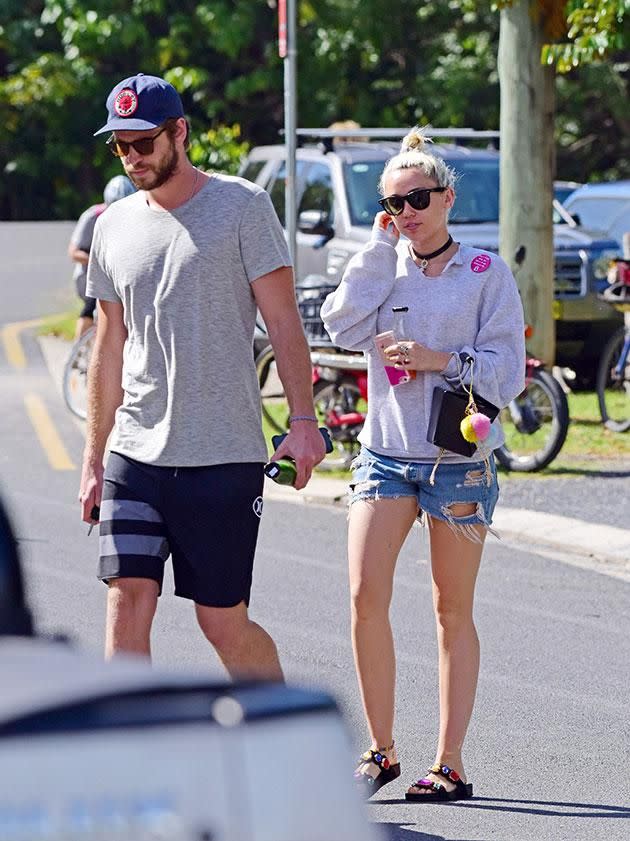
left=597, top=327, right=630, bottom=432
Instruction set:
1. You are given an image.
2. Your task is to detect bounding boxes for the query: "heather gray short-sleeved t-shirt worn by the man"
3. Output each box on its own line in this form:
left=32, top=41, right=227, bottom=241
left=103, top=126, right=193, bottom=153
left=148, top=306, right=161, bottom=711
left=87, top=175, right=291, bottom=467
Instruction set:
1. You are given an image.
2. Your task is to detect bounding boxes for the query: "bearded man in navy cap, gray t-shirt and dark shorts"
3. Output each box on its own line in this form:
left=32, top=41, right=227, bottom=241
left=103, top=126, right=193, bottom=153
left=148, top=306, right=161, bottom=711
left=80, top=73, right=324, bottom=680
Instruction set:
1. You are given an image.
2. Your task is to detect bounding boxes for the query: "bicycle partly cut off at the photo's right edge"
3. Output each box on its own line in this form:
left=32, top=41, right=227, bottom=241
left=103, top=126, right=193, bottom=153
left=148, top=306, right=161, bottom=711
left=596, top=259, right=630, bottom=432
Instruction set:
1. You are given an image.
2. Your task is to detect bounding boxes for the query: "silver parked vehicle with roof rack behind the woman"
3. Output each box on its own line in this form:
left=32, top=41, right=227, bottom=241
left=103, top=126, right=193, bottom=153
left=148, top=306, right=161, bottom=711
left=240, top=133, right=620, bottom=386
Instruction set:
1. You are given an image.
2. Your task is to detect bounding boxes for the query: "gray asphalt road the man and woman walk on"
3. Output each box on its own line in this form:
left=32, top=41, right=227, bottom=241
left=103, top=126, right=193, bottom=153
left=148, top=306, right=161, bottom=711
left=0, top=226, right=630, bottom=841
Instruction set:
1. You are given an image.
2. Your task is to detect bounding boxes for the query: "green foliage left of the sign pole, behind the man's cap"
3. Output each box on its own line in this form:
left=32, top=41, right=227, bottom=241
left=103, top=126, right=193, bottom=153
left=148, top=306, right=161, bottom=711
left=0, top=0, right=282, bottom=219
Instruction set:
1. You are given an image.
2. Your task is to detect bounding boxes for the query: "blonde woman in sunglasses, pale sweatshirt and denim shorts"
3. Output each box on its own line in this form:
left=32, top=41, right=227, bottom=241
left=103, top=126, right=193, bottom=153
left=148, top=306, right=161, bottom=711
left=322, top=129, right=525, bottom=802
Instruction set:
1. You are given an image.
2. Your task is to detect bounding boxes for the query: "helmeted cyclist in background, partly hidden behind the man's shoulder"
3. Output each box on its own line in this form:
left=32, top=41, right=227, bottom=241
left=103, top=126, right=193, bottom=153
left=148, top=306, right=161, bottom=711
left=68, top=175, right=136, bottom=340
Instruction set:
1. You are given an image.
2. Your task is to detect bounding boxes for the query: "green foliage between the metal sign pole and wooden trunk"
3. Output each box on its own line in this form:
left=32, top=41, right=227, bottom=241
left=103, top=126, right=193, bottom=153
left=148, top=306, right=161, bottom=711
left=298, top=0, right=498, bottom=128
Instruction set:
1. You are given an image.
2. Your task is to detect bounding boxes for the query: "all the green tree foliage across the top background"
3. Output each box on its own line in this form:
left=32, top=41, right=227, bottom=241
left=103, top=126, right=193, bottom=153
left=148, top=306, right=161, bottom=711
left=0, top=0, right=630, bottom=219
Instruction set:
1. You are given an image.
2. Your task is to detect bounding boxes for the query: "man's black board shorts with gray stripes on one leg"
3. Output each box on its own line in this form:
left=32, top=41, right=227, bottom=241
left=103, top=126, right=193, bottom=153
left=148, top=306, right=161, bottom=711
left=98, top=453, right=264, bottom=607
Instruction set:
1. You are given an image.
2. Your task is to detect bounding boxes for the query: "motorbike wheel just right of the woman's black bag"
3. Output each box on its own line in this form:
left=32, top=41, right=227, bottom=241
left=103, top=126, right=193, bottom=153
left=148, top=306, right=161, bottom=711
left=495, top=368, right=569, bottom=473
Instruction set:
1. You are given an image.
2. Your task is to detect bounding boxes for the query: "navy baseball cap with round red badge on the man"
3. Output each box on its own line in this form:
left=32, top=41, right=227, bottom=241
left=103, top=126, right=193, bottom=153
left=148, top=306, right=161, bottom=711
left=94, top=73, right=184, bottom=136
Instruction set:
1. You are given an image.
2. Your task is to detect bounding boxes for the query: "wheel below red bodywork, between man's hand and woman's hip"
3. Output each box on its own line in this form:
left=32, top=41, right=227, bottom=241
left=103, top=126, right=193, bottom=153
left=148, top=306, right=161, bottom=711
left=313, top=376, right=367, bottom=470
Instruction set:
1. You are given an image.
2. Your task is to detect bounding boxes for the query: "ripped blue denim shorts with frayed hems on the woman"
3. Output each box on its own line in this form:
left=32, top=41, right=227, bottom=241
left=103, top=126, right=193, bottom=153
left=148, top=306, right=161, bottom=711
left=350, top=447, right=499, bottom=540
